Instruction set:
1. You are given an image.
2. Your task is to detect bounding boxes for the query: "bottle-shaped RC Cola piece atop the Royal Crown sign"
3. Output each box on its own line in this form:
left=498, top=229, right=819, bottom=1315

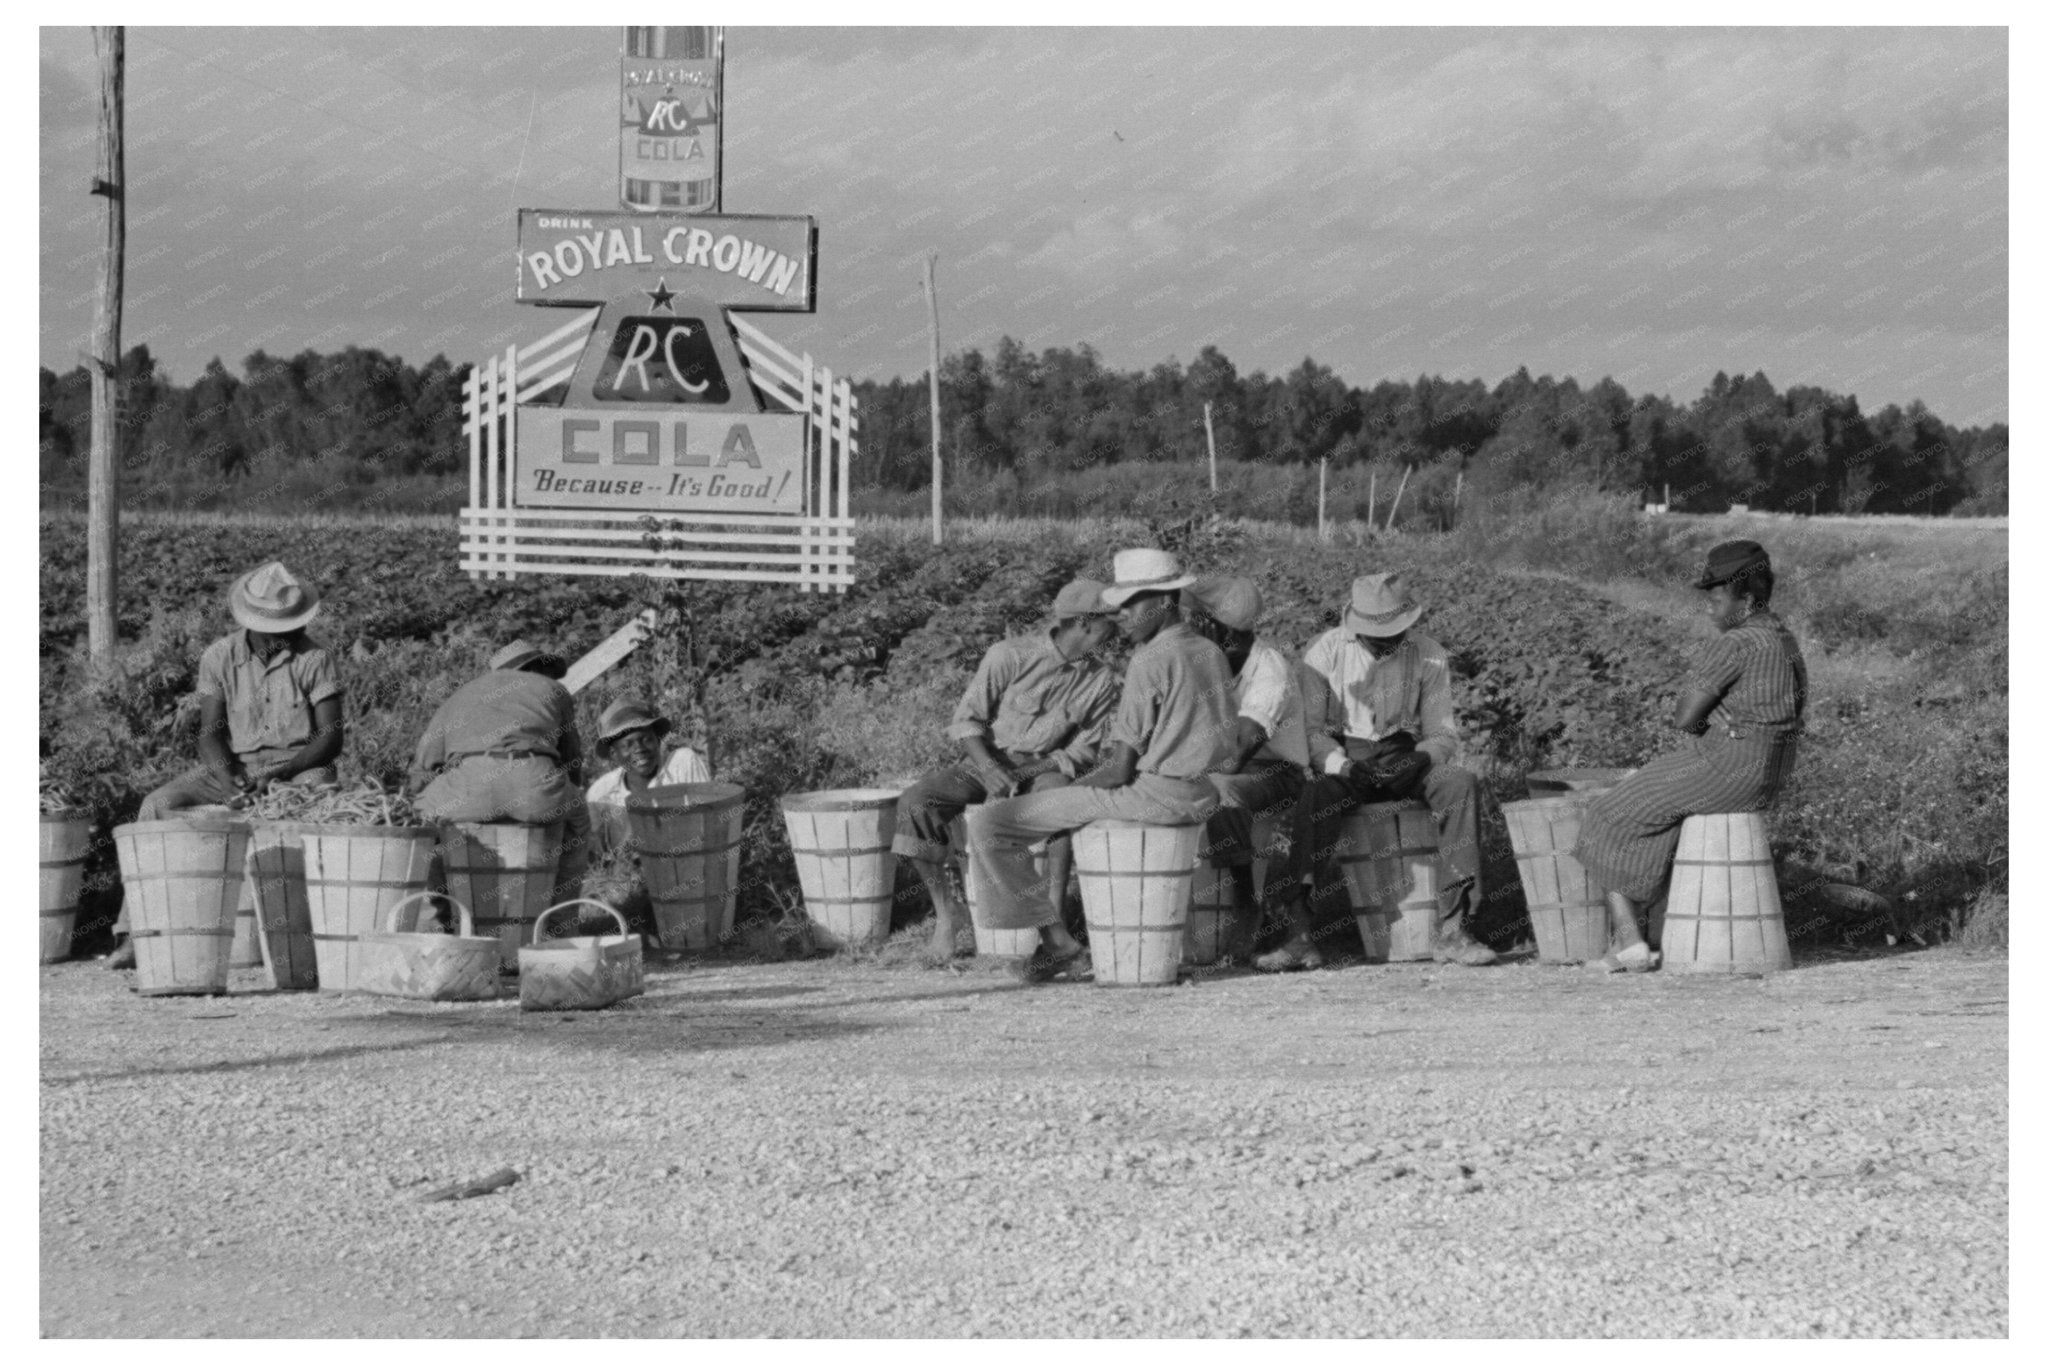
left=618, top=25, right=725, bottom=213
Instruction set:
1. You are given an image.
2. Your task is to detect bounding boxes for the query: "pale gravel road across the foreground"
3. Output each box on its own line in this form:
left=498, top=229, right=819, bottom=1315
left=41, top=950, right=2009, bottom=1336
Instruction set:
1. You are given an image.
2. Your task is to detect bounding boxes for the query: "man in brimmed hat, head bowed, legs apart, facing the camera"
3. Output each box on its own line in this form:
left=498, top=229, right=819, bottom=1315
left=1257, top=573, right=1495, bottom=970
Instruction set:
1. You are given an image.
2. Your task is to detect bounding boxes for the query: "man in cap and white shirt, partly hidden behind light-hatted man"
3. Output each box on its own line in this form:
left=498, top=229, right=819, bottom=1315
left=1180, top=577, right=1309, bottom=960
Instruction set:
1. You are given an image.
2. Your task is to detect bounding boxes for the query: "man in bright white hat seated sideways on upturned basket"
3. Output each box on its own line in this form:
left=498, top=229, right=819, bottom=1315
left=969, top=551, right=1237, bottom=982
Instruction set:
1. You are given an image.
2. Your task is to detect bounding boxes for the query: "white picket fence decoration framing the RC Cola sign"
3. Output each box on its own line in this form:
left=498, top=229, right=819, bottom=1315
left=461, top=309, right=860, bottom=591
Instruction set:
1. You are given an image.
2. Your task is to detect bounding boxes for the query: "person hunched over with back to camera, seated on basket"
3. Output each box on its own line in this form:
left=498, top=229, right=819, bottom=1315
left=412, top=641, right=590, bottom=905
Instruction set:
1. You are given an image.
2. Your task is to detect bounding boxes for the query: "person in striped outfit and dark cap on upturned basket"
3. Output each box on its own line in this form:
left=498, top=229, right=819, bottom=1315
left=1573, top=540, right=1806, bottom=972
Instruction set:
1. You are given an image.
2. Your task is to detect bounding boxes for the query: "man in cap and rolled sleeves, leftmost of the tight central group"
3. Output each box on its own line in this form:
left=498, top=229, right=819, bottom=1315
left=893, top=579, right=1116, bottom=962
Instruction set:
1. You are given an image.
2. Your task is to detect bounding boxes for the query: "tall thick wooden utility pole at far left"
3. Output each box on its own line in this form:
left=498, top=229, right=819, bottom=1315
left=86, top=25, right=127, bottom=665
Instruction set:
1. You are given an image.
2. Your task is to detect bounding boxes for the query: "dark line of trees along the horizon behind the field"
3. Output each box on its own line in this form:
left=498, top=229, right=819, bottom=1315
left=39, top=338, right=2007, bottom=516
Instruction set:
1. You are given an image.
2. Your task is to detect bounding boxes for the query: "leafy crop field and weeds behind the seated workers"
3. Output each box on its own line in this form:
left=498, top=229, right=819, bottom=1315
left=39, top=503, right=2009, bottom=950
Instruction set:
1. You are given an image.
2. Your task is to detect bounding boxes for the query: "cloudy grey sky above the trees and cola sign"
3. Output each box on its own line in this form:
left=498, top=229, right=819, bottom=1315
left=39, top=27, right=2009, bottom=426
